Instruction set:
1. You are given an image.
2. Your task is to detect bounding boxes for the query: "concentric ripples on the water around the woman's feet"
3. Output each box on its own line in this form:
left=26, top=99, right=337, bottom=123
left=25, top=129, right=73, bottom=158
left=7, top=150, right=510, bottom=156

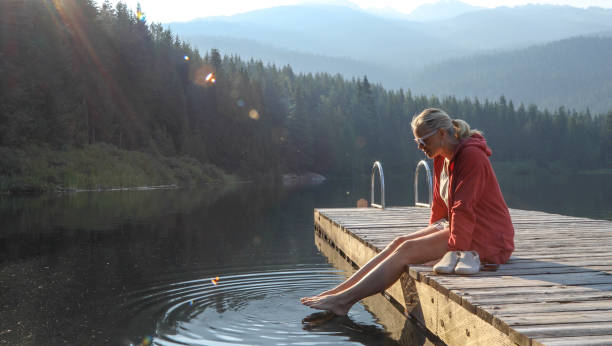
left=122, top=265, right=382, bottom=345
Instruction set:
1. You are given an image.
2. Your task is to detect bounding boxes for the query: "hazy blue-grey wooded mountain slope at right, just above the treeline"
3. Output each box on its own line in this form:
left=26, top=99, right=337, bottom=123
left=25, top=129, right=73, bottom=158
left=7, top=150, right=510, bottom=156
left=409, top=37, right=612, bottom=113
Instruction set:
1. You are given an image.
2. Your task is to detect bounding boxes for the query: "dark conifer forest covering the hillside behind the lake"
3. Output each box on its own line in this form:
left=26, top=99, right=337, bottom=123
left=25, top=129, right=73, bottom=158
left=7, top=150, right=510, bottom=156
left=0, top=0, right=612, bottom=189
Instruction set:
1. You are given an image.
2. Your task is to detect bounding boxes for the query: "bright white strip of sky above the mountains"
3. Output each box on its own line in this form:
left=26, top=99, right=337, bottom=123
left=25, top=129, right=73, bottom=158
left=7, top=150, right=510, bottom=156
left=98, top=0, right=612, bottom=23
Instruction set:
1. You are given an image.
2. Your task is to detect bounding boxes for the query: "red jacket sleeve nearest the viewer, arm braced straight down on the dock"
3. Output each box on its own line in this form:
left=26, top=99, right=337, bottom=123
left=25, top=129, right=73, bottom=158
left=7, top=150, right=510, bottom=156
left=448, top=148, right=488, bottom=251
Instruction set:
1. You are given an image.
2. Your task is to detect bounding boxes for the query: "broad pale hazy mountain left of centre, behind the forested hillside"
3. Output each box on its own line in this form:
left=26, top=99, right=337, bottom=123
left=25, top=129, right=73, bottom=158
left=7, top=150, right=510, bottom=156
left=169, top=5, right=468, bottom=70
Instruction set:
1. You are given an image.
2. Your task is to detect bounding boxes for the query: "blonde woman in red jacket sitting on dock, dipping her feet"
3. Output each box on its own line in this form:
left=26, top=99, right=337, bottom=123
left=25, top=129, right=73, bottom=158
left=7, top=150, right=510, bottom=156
left=301, top=108, right=514, bottom=315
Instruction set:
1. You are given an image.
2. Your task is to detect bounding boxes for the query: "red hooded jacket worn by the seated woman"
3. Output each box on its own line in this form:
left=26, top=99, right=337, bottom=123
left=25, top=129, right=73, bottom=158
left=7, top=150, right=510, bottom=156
left=430, top=134, right=514, bottom=263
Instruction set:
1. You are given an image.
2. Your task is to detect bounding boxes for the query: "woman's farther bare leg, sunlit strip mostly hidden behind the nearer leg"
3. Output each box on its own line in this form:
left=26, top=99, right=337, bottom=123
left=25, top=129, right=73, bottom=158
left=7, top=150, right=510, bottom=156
left=301, top=226, right=439, bottom=303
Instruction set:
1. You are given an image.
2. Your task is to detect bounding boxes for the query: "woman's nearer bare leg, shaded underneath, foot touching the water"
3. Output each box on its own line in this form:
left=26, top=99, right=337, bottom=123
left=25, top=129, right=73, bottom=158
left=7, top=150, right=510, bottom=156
left=304, top=229, right=449, bottom=315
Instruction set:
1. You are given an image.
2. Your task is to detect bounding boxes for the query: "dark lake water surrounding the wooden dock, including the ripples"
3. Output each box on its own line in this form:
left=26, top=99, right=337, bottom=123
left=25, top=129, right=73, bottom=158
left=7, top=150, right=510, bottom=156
left=0, top=175, right=612, bottom=345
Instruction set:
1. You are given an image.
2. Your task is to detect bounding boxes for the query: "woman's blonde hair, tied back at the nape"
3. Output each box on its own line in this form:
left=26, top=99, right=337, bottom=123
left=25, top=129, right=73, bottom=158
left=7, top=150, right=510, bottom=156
left=410, top=108, right=482, bottom=139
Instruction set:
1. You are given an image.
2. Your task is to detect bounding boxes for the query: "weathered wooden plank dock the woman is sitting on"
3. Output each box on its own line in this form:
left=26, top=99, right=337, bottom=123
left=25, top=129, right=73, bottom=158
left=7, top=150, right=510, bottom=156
left=314, top=207, right=612, bottom=345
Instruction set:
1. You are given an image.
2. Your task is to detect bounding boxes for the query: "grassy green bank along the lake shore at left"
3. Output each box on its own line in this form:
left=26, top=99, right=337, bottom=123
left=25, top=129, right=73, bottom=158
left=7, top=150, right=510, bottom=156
left=0, top=144, right=237, bottom=193
